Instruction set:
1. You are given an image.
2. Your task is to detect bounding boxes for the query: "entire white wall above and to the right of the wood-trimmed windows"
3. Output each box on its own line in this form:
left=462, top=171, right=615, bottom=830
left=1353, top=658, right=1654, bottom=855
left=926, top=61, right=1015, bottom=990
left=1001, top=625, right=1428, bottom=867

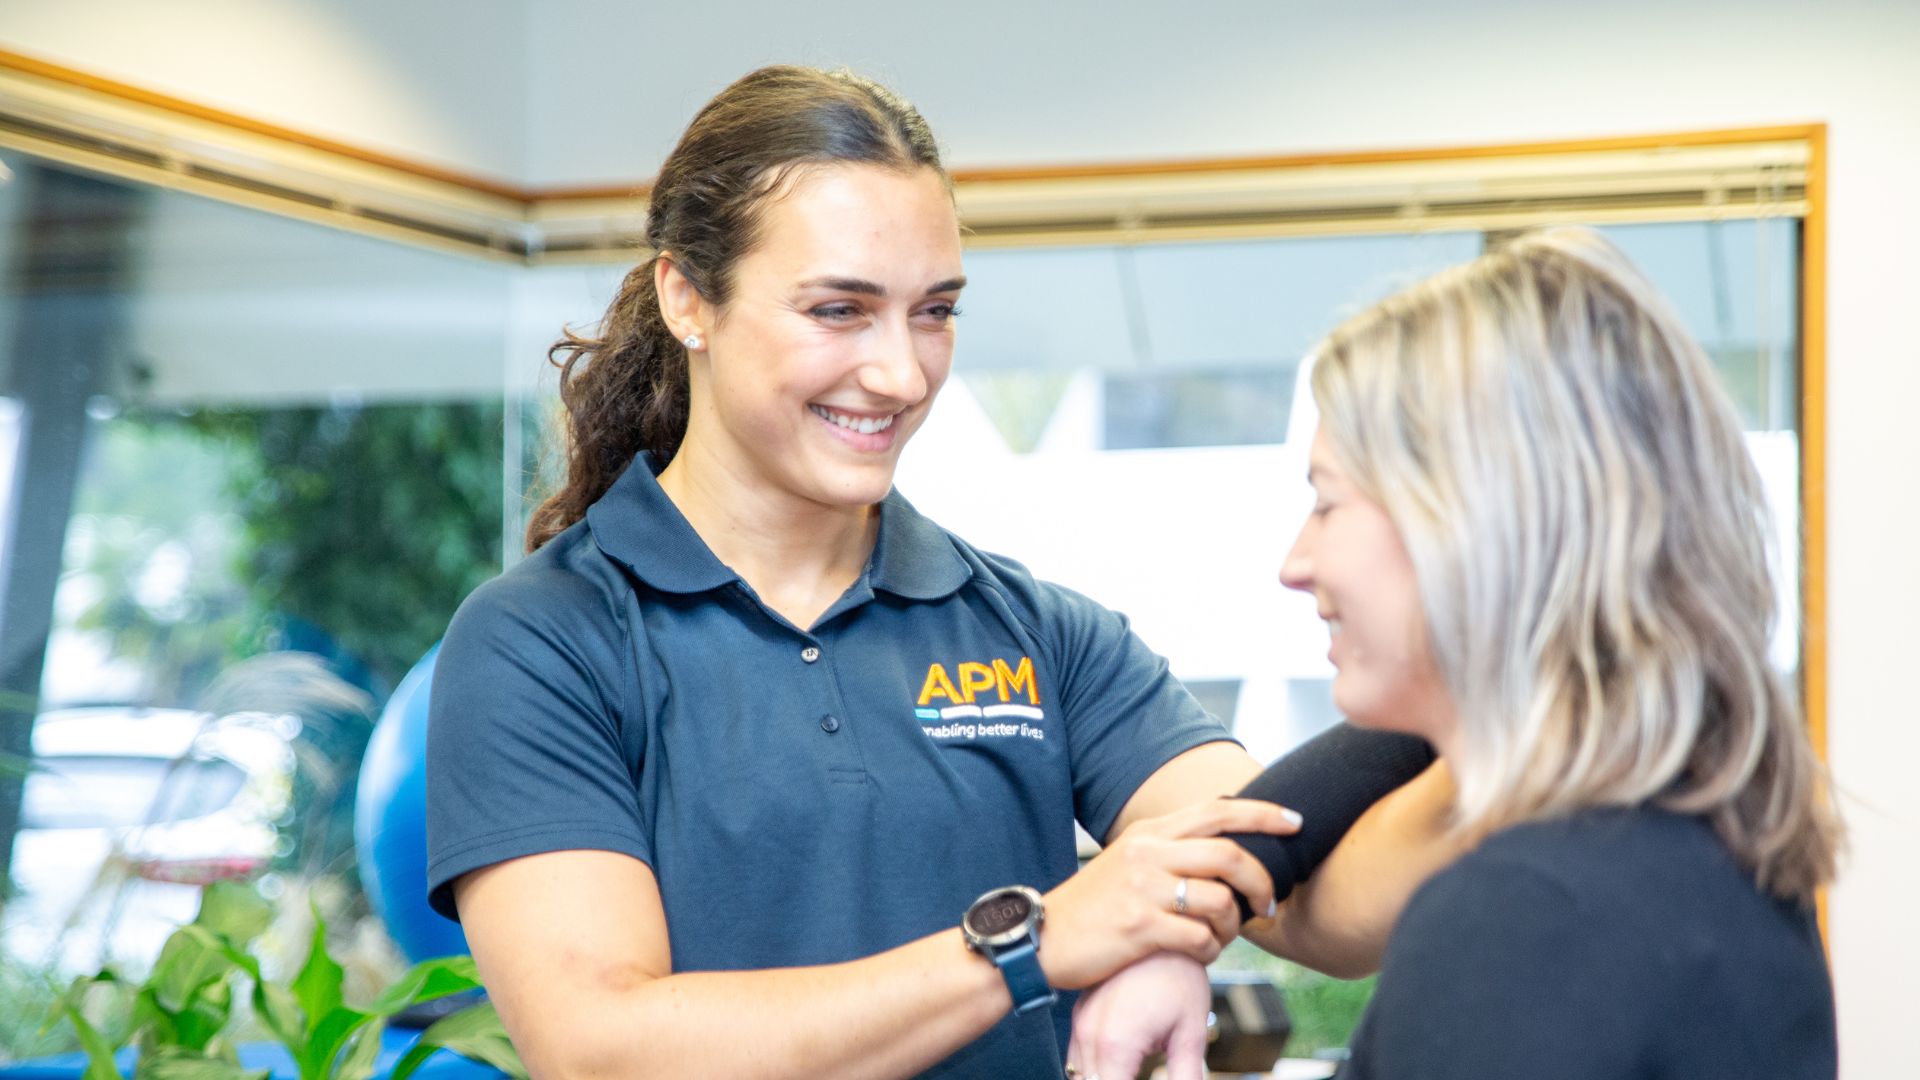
left=0, top=0, right=1920, bottom=1080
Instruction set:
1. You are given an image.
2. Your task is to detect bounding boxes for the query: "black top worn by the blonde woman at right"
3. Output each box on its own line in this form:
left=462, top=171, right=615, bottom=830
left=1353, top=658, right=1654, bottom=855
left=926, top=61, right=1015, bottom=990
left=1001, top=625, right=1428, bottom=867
left=1340, top=809, right=1837, bottom=1080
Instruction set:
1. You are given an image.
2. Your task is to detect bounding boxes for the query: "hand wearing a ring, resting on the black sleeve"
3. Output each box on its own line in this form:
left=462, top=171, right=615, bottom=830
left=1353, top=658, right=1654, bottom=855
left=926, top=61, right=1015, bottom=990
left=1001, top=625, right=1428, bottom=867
left=1041, top=799, right=1300, bottom=990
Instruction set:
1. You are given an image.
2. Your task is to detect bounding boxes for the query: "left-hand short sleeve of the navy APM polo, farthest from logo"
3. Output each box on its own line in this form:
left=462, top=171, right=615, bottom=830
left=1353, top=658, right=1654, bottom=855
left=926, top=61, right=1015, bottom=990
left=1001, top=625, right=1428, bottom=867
left=426, top=555, right=653, bottom=920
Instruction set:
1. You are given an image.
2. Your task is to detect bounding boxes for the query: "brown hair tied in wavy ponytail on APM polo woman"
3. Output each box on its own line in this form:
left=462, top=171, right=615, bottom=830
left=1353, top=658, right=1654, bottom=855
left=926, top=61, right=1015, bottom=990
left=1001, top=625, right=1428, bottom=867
left=526, top=67, right=947, bottom=552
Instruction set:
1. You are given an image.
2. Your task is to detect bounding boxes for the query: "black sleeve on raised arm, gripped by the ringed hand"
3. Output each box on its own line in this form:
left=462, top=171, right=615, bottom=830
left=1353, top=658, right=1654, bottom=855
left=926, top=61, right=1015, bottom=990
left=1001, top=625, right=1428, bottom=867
left=1231, top=723, right=1434, bottom=919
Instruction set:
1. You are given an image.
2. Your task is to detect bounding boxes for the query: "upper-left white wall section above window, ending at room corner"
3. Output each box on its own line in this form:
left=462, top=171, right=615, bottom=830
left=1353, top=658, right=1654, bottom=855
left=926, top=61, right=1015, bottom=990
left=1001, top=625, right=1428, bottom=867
left=0, top=0, right=530, bottom=179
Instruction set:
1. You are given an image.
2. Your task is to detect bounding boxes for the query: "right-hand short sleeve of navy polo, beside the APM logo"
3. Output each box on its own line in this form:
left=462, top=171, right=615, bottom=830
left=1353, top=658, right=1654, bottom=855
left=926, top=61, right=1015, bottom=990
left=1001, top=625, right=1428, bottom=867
left=1043, top=586, right=1233, bottom=842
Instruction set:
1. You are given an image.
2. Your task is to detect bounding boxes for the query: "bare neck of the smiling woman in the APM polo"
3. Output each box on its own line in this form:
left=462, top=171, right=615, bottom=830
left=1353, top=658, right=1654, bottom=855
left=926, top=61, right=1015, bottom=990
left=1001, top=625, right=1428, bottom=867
left=660, top=452, right=879, bottom=630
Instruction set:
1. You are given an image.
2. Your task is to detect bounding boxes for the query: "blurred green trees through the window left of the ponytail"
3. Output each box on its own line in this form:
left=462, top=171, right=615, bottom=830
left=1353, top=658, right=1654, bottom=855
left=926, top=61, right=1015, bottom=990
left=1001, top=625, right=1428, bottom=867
left=67, top=402, right=503, bottom=703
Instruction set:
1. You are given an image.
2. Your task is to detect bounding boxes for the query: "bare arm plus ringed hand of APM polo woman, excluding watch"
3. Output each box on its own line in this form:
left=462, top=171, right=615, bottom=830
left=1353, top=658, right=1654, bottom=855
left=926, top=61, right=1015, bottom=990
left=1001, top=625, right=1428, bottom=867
left=455, top=801, right=1290, bottom=1080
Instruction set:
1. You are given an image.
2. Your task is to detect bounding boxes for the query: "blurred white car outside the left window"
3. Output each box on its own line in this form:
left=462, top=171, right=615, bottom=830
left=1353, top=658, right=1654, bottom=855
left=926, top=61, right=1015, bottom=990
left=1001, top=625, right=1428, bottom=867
left=0, top=705, right=301, bottom=974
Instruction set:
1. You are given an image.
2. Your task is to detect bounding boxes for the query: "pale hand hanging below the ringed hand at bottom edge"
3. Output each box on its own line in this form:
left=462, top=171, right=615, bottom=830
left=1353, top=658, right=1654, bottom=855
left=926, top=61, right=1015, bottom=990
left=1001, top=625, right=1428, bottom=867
left=1068, top=953, right=1213, bottom=1080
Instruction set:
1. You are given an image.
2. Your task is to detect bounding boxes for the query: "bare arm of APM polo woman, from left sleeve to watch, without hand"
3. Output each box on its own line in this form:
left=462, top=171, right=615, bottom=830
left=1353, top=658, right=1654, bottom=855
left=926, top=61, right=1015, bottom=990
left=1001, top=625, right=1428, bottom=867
left=455, top=851, right=1012, bottom=1080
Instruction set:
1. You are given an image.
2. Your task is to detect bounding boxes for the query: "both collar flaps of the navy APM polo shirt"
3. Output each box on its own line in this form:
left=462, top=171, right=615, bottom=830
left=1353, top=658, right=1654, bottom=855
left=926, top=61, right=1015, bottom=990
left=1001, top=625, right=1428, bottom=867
left=588, top=452, right=973, bottom=600
